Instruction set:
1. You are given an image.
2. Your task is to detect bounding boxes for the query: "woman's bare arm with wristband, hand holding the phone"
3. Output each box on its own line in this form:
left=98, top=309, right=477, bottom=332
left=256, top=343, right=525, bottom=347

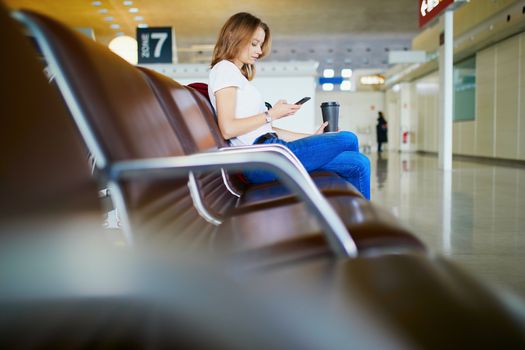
left=215, top=86, right=301, bottom=140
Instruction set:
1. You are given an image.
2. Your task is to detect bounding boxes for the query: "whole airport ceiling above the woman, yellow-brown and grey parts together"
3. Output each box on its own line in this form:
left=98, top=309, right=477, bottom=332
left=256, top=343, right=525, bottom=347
left=5, top=0, right=419, bottom=69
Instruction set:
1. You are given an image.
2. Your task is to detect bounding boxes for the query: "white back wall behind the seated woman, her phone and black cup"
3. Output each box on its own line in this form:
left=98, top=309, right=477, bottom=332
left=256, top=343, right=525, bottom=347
left=140, top=61, right=388, bottom=139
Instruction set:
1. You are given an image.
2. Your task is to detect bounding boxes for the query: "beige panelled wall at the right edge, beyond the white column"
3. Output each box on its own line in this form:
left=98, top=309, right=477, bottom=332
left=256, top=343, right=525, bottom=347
left=454, top=33, right=525, bottom=160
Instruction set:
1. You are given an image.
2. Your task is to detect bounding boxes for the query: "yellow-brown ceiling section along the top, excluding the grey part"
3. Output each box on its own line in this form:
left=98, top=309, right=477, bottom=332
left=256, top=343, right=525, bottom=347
left=5, top=0, right=417, bottom=43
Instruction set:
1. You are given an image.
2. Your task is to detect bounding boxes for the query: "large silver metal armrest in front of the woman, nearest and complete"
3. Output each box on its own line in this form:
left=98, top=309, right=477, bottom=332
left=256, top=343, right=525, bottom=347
left=108, top=149, right=357, bottom=257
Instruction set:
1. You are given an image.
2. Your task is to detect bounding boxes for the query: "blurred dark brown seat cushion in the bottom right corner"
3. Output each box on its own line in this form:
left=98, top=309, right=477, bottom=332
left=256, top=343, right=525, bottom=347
left=246, top=254, right=525, bottom=349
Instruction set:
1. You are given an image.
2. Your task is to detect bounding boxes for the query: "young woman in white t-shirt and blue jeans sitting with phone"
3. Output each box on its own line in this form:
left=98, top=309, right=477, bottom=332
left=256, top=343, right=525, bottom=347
left=208, top=12, right=370, bottom=199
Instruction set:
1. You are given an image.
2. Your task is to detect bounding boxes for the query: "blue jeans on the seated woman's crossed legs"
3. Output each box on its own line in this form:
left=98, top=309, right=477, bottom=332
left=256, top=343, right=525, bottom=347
left=244, top=131, right=370, bottom=199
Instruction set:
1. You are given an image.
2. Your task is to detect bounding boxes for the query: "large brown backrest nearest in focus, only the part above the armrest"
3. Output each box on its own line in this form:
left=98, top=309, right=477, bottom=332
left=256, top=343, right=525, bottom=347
left=26, top=11, right=183, bottom=162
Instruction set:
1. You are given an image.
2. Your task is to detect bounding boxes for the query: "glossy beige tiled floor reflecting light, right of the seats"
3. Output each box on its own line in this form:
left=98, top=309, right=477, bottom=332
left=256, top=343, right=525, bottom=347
left=369, top=152, right=525, bottom=298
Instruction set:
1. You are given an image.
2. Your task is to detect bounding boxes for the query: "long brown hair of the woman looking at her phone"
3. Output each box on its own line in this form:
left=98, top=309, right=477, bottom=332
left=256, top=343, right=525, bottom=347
left=211, top=12, right=272, bottom=80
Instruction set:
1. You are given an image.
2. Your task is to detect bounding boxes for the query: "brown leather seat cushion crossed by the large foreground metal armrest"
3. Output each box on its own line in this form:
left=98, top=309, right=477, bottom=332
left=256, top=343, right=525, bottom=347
left=215, top=196, right=418, bottom=255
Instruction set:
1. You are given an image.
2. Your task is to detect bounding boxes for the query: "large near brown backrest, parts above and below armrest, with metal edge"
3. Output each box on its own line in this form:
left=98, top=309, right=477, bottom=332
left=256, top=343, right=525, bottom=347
left=17, top=11, right=214, bottom=243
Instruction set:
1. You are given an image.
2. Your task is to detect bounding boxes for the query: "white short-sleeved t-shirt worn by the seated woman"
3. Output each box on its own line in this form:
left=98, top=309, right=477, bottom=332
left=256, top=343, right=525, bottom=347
left=208, top=60, right=273, bottom=146
